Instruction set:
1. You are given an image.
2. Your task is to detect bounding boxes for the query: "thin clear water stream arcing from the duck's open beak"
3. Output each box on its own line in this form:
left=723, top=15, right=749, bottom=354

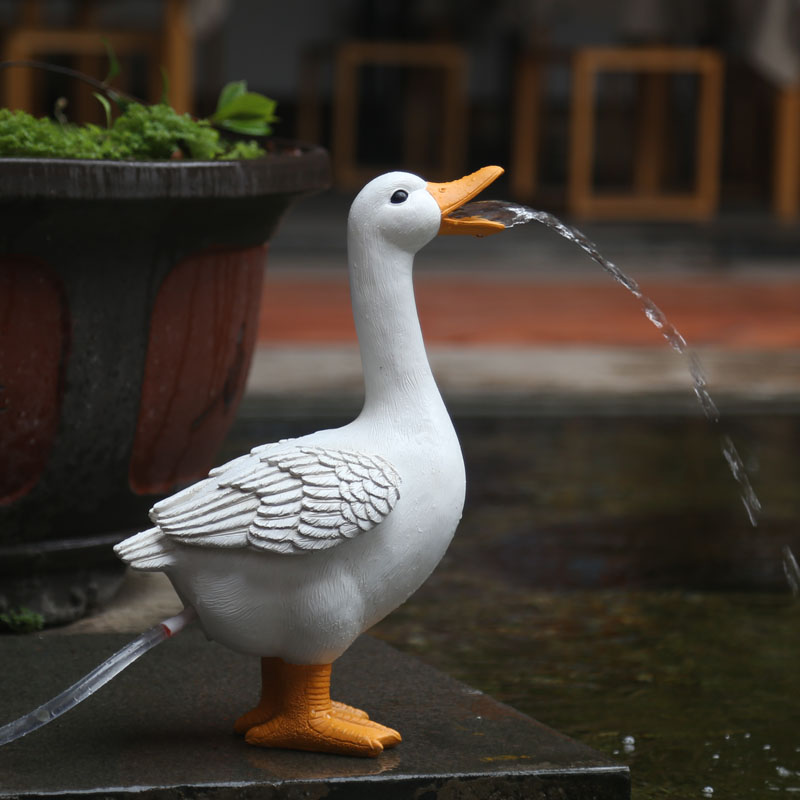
left=451, top=200, right=764, bottom=532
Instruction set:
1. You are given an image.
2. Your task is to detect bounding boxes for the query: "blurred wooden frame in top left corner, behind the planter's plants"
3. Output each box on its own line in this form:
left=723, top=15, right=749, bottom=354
left=0, top=0, right=194, bottom=113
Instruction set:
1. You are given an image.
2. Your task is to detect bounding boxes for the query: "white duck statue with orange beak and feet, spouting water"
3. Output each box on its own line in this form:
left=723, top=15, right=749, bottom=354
left=116, top=167, right=503, bottom=756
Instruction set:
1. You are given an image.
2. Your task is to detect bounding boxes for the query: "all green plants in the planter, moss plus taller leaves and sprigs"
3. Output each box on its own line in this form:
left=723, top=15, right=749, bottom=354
left=0, top=52, right=276, bottom=161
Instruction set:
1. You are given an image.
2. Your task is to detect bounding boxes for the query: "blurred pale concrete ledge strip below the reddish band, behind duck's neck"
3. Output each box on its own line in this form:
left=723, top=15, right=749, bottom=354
left=247, top=345, right=800, bottom=400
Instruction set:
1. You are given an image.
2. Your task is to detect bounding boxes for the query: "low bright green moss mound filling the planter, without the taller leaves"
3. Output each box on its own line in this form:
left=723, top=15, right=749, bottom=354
left=0, top=103, right=264, bottom=161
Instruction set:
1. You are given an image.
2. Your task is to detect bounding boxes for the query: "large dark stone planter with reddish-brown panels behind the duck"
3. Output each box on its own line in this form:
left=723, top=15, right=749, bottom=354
left=0, top=146, right=329, bottom=622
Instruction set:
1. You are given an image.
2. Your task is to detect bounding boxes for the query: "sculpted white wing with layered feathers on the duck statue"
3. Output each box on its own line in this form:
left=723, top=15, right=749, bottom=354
left=150, top=447, right=400, bottom=554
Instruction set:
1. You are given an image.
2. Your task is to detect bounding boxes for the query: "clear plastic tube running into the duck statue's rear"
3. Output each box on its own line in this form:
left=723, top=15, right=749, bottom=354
left=0, top=607, right=197, bottom=747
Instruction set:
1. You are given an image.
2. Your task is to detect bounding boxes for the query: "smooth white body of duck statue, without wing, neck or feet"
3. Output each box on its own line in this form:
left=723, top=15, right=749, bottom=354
left=147, top=406, right=465, bottom=664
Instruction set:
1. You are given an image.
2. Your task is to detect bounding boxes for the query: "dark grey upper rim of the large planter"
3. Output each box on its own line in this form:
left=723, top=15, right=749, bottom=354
left=0, top=140, right=331, bottom=201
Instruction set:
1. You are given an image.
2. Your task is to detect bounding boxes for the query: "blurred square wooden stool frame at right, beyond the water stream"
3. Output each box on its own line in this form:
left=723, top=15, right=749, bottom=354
left=567, top=47, right=724, bottom=220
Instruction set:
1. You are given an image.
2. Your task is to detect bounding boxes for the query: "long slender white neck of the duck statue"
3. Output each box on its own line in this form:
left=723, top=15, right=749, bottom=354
left=349, top=234, right=443, bottom=419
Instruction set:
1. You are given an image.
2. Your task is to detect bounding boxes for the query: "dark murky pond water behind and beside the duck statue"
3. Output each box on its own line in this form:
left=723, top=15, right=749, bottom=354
left=223, top=402, right=800, bottom=800
